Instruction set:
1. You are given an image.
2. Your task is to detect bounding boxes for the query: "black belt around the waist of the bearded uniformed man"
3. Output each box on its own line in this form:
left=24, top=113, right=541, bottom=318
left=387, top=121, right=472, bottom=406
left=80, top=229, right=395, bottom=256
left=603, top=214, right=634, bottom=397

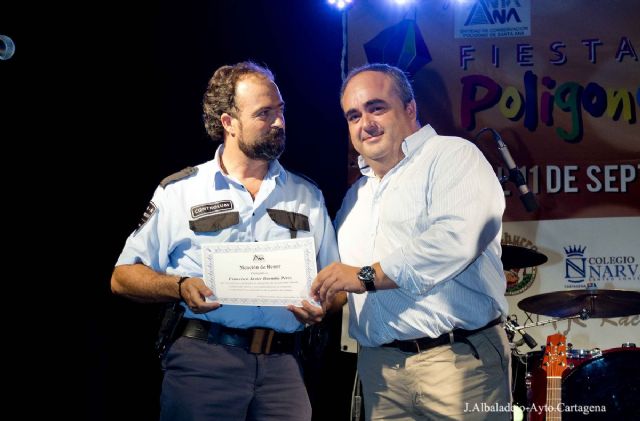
left=181, top=319, right=302, bottom=354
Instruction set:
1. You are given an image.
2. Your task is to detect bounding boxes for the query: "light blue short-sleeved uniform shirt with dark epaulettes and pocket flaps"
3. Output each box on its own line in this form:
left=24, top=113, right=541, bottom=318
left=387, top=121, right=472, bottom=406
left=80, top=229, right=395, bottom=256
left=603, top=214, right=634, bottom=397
left=116, top=146, right=339, bottom=332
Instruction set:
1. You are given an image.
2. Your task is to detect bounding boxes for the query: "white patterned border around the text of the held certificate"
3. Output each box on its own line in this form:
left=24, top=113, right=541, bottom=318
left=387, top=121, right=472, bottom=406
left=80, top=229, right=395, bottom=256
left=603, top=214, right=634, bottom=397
left=202, top=237, right=317, bottom=306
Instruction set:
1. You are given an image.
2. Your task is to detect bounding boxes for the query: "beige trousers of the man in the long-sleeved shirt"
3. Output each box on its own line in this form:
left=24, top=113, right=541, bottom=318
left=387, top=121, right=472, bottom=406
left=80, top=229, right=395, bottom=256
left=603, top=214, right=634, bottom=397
left=358, top=325, right=511, bottom=421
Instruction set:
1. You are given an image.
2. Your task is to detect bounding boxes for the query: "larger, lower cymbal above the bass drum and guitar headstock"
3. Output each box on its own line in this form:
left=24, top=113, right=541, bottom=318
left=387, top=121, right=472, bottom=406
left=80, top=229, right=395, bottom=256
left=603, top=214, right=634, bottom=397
left=518, top=289, right=640, bottom=318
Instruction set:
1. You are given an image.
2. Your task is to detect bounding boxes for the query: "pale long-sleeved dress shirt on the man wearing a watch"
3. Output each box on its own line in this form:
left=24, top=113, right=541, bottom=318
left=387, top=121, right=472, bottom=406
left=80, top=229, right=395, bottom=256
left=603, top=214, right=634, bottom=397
left=335, top=126, right=507, bottom=346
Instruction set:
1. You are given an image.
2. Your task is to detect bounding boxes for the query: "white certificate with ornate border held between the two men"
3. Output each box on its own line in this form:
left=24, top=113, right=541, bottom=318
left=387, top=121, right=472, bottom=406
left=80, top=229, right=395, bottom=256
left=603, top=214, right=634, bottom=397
left=202, top=237, right=317, bottom=306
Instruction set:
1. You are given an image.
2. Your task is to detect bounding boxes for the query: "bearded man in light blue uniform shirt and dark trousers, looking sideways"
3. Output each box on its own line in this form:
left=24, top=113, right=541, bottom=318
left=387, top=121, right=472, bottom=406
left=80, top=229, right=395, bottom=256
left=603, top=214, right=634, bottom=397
left=111, top=62, right=338, bottom=420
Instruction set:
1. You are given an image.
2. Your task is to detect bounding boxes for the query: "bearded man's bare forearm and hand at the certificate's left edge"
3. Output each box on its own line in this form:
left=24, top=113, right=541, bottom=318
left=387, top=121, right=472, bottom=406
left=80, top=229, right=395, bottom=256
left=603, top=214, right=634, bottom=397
left=111, top=264, right=220, bottom=313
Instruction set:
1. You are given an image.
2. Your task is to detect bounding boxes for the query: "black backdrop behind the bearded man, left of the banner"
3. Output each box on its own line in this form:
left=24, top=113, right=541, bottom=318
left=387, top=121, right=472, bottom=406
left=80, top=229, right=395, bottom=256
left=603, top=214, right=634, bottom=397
left=0, top=0, right=355, bottom=420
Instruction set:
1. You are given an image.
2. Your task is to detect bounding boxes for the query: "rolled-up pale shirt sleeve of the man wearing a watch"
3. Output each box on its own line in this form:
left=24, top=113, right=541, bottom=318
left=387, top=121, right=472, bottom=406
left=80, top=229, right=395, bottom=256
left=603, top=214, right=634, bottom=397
left=380, top=144, right=504, bottom=295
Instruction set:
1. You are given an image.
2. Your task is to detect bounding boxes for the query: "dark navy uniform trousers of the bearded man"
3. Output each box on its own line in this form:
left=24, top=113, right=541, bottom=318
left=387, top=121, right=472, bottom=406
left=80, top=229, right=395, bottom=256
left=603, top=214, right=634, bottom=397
left=160, top=336, right=311, bottom=421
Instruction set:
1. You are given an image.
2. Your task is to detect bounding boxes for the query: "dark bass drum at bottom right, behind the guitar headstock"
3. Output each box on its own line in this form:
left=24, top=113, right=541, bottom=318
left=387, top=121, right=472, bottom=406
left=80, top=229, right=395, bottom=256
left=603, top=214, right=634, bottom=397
left=562, top=347, right=640, bottom=421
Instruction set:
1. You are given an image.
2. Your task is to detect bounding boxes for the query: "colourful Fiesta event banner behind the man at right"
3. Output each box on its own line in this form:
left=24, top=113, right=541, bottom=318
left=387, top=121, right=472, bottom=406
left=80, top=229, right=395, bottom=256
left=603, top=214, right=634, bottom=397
left=347, top=0, right=640, bottom=348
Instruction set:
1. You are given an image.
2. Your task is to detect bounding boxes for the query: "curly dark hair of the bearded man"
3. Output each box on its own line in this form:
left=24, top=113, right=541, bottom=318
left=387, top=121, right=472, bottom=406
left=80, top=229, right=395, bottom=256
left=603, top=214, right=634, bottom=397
left=202, top=61, right=274, bottom=141
